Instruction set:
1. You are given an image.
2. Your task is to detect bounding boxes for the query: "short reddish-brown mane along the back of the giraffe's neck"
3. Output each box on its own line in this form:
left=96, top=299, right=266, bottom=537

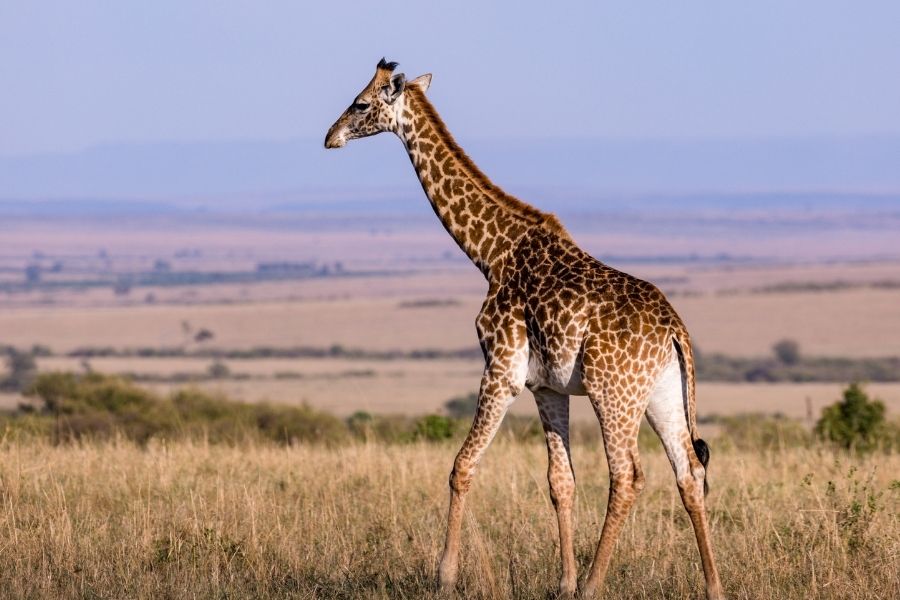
left=405, top=86, right=570, bottom=239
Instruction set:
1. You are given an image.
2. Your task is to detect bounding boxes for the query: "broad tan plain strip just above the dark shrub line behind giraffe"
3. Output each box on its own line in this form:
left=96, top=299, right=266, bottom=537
left=0, top=269, right=900, bottom=357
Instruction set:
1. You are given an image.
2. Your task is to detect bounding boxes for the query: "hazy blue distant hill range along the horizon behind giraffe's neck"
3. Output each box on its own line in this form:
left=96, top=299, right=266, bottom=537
left=0, top=136, right=900, bottom=207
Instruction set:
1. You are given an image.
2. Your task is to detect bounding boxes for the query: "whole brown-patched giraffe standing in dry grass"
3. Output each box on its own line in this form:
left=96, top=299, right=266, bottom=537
left=325, top=58, right=724, bottom=600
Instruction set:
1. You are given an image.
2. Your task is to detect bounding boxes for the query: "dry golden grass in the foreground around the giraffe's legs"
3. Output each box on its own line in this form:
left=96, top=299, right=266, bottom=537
left=0, top=440, right=900, bottom=599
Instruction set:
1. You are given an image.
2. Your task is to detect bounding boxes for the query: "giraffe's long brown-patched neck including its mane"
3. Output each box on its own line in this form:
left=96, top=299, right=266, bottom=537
left=396, top=86, right=566, bottom=279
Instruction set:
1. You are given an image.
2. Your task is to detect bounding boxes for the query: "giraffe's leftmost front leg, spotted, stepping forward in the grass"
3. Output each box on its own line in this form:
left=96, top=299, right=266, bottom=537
left=439, top=373, right=519, bottom=590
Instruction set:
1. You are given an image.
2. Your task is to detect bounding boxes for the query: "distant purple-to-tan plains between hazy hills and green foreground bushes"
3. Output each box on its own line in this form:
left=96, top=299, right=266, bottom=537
left=0, top=209, right=900, bottom=418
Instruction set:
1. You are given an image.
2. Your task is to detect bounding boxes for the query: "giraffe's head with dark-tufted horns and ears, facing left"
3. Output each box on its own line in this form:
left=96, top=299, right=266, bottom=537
left=325, top=58, right=431, bottom=148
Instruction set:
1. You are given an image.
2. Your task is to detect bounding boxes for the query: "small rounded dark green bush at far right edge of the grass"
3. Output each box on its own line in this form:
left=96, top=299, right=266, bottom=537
left=815, top=383, right=886, bottom=452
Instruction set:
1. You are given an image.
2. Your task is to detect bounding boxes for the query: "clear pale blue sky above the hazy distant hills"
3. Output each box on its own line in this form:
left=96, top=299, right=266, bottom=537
left=0, top=0, right=900, bottom=156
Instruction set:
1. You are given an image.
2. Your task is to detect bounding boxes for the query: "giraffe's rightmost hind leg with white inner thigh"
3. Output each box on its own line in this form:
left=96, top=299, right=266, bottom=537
left=647, top=360, right=724, bottom=600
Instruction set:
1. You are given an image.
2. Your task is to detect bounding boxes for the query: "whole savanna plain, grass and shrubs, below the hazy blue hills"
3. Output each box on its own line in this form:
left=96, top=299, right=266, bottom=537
left=0, top=200, right=900, bottom=599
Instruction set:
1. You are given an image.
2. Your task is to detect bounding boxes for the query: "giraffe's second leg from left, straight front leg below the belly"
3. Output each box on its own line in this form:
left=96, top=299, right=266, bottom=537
left=534, top=389, right=578, bottom=597
